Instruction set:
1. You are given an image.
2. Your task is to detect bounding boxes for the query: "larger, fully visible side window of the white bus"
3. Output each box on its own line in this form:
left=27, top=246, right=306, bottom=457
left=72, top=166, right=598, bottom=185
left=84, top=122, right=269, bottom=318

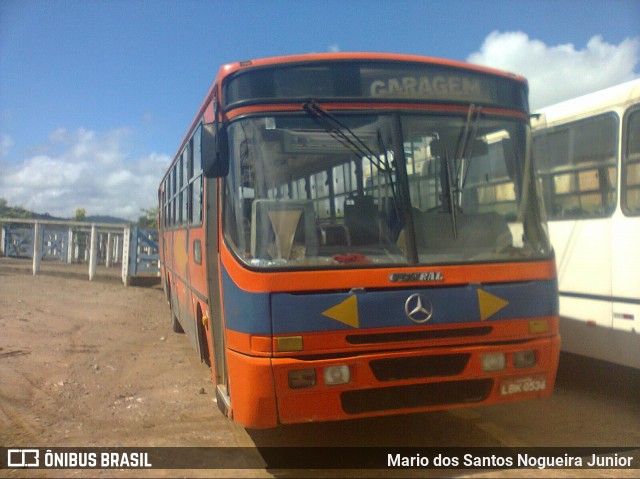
left=534, top=114, right=618, bottom=219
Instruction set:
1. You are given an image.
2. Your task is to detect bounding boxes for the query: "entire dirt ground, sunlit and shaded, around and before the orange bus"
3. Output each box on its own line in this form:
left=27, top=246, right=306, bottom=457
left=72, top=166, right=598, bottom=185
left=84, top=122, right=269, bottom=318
left=0, top=258, right=639, bottom=478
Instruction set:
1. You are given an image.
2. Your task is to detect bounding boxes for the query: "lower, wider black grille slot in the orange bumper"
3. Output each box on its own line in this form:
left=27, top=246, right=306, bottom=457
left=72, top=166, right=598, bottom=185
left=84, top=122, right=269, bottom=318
left=340, top=379, right=493, bottom=414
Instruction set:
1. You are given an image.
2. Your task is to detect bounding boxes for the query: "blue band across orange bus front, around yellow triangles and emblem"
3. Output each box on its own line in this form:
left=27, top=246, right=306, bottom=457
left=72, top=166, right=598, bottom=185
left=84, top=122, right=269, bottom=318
left=222, top=268, right=558, bottom=335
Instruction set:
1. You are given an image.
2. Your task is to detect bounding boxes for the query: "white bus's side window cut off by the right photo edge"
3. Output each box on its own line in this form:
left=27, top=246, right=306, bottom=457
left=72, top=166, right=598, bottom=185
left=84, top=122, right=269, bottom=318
left=622, top=106, right=640, bottom=216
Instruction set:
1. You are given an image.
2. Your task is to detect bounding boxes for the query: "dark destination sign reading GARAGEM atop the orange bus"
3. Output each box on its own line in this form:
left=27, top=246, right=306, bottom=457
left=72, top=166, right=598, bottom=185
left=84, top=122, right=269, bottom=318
left=223, top=60, right=528, bottom=111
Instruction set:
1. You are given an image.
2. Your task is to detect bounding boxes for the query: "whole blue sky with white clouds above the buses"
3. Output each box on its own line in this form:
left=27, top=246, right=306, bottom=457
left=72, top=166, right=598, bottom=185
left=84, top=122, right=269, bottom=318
left=0, top=0, right=640, bottom=220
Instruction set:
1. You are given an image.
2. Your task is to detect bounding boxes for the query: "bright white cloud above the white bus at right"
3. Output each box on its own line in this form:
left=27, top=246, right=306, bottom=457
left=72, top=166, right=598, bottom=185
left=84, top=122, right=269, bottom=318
left=467, top=32, right=640, bottom=110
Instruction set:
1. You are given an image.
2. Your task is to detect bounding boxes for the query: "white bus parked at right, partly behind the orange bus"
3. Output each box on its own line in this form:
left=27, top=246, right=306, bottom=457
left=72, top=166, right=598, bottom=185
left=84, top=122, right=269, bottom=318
left=534, top=79, right=640, bottom=368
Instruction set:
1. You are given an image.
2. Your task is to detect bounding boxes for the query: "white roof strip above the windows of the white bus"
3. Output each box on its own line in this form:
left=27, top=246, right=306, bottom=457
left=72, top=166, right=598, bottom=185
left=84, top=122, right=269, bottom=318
left=536, top=78, right=640, bottom=128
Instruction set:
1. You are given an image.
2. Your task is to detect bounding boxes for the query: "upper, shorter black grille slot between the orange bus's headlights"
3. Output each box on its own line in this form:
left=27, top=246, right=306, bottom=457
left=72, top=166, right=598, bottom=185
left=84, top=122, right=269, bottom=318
left=369, top=354, right=471, bottom=381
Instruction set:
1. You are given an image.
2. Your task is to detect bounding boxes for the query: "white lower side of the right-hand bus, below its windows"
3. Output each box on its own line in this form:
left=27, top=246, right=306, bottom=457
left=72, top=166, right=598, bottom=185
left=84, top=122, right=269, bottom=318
left=549, top=213, right=640, bottom=368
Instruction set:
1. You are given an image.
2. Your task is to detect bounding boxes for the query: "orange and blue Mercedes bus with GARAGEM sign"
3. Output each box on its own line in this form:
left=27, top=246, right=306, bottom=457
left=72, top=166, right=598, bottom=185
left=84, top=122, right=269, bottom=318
left=159, top=53, right=560, bottom=428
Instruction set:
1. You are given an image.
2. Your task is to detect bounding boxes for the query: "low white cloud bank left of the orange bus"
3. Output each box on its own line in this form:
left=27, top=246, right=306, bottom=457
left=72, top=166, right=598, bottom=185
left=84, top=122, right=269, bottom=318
left=0, top=128, right=170, bottom=220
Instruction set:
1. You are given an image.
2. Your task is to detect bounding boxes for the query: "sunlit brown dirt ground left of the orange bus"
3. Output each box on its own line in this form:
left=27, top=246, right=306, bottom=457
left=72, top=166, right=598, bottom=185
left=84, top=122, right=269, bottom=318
left=0, top=258, right=264, bottom=476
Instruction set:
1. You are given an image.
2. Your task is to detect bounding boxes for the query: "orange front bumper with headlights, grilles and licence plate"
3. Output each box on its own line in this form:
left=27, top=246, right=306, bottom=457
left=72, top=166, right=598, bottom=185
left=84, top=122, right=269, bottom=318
left=272, top=336, right=560, bottom=424
